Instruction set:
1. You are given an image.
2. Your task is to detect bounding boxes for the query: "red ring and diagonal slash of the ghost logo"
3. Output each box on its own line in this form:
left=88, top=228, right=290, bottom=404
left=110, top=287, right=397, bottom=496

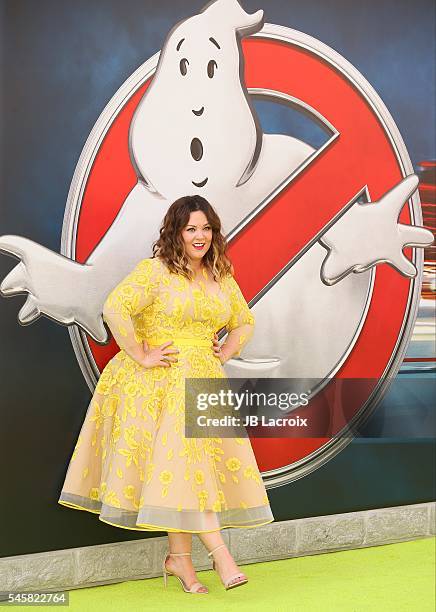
left=76, top=37, right=412, bottom=471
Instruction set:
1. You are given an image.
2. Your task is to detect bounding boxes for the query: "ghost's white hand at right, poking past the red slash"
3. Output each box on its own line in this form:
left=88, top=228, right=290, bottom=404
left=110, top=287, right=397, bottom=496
left=320, top=174, right=434, bottom=285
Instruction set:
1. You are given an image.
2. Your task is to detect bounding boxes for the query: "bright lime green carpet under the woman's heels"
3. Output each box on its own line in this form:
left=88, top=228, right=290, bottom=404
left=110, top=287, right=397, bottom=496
left=4, top=538, right=436, bottom=612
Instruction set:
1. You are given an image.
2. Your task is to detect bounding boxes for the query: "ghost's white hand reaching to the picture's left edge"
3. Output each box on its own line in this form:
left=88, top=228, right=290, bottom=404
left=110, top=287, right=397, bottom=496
left=0, top=236, right=108, bottom=342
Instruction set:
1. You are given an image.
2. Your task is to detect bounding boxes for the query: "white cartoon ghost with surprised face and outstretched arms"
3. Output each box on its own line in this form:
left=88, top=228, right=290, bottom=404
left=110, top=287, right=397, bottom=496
left=0, top=0, right=433, bottom=392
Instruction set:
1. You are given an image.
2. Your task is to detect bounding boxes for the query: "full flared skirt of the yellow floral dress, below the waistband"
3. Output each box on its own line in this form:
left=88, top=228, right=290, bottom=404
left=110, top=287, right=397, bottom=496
left=58, top=347, right=274, bottom=533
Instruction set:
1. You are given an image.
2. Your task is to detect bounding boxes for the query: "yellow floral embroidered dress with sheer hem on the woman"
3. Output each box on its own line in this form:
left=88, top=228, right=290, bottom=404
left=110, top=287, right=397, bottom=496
left=58, top=258, right=274, bottom=533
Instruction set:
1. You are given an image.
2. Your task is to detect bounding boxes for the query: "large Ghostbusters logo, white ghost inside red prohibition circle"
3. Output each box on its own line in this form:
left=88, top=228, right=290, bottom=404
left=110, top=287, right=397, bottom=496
left=0, top=0, right=433, bottom=556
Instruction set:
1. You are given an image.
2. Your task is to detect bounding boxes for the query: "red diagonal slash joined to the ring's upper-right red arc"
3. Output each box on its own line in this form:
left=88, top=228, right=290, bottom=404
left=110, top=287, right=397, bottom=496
left=229, top=38, right=409, bottom=301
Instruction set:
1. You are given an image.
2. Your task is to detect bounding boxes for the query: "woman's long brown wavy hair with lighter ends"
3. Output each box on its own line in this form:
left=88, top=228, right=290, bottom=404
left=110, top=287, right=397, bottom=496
left=153, top=195, right=233, bottom=282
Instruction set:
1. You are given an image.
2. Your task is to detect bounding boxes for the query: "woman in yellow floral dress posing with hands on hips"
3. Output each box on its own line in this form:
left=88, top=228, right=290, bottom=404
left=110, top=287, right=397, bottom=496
left=59, top=196, right=274, bottom=593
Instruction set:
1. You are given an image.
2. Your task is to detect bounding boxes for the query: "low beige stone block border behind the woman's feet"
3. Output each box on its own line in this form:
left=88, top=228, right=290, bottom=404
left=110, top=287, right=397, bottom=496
left=0, top=502, right=436, bottom=601
